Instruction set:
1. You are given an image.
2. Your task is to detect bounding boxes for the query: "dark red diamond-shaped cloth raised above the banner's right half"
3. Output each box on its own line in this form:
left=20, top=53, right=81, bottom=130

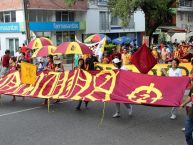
left=131, top=45, right=157, bottom=74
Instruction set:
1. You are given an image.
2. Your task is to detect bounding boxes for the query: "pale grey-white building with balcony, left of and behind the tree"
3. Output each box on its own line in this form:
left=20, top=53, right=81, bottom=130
left=84, top=0, right=145, bottom=46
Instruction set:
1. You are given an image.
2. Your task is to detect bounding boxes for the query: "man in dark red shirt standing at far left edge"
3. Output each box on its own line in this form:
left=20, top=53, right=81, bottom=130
left=0, top=50, right=10, bottom=77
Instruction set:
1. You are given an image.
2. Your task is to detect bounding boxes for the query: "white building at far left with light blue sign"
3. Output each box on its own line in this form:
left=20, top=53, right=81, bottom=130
left=0, top=0, right=26, bottom=56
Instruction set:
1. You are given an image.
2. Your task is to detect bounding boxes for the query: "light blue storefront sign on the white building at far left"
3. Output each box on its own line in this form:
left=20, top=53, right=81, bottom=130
left=0, top=23, right=21, bottom=33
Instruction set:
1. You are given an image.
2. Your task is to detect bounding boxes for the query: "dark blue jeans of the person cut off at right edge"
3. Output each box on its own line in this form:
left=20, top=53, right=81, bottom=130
left=185, top=117, right=193, bottom=145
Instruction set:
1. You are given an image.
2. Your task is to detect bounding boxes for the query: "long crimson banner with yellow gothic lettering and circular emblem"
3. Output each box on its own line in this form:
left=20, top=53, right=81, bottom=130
left=0, top=69, right=189, bottom=106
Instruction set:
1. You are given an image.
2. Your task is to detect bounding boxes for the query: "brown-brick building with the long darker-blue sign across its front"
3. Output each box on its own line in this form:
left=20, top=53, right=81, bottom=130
left=28, top=0, right=87, bottom=45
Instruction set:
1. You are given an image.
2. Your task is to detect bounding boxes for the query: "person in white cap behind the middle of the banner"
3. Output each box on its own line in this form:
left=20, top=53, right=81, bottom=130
left=112, top=58, right=133, bottom=118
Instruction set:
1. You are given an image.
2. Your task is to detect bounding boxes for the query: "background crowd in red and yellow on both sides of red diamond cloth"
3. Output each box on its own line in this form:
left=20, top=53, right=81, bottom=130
left=100, top=42, right=193, bottom=65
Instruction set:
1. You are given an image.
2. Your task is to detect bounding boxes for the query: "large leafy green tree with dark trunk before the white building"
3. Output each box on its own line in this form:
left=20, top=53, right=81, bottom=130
left=109, top=0, right=176, bottom=43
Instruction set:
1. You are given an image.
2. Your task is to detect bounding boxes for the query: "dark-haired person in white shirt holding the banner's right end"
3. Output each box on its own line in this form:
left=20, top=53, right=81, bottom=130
left=162, top=58, right=182, bottom=120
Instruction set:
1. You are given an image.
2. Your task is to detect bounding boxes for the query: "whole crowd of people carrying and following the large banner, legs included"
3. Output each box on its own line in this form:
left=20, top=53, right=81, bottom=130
left=0, top=42, right=193, bottom=145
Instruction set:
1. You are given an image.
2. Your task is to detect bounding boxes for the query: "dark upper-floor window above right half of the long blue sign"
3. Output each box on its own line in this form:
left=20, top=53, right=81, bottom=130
left=56, top=11, right=75, bottom=21
